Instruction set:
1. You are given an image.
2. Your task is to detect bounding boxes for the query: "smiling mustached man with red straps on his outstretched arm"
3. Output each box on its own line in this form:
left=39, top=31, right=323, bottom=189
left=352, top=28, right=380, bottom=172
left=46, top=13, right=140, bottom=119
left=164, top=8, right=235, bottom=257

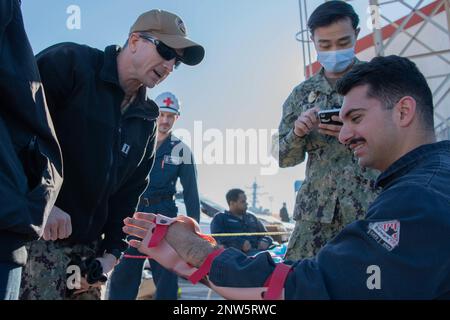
left=124, top=56, right=450, bottom=299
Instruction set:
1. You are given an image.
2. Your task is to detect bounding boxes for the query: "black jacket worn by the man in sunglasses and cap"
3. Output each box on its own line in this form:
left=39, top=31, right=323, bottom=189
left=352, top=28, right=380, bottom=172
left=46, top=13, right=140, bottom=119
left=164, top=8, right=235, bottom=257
left=37, top=43, right=159, bottom=255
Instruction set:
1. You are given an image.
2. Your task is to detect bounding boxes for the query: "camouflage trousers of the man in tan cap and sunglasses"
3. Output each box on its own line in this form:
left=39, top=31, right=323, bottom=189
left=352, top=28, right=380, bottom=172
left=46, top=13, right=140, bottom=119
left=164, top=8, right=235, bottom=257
left=20, top=240, right=101, bottom=300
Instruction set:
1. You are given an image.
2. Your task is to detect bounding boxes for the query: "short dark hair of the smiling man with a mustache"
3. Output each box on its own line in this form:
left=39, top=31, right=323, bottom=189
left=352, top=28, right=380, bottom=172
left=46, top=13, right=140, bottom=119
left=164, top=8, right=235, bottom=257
left=336, top=55, right=434, bottom=130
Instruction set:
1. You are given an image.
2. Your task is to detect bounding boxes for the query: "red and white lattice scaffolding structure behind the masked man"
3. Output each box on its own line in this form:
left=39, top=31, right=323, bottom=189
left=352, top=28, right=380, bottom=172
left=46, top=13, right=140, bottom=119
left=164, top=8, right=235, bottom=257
left=296, top=0, right=450, bottom=140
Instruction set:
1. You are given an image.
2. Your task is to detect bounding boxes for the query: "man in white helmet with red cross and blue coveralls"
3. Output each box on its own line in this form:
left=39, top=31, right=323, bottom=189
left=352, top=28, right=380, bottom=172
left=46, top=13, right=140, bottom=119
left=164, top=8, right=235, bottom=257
left=108, top=92, right=200, bottom=300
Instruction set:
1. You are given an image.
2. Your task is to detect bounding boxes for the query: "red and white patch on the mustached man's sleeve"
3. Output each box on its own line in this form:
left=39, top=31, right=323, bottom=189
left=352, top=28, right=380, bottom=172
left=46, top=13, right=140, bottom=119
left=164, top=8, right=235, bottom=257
left=367, top=220, right=400, bottom=251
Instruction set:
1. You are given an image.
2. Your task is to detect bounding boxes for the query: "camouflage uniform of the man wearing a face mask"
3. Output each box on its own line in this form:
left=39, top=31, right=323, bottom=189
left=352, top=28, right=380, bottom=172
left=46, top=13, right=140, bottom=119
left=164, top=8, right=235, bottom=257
left=275, top=61, right=378, bottom=260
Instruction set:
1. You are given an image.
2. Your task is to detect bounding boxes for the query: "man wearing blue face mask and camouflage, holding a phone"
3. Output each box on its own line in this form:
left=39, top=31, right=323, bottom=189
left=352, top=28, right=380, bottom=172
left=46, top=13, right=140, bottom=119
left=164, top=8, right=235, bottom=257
left=274, top=1, right=376, bottom=260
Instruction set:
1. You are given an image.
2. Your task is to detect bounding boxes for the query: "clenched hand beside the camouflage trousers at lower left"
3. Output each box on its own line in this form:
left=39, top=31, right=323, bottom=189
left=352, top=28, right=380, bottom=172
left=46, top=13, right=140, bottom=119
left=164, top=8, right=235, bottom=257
left=43, top=206, right=72, bottom=241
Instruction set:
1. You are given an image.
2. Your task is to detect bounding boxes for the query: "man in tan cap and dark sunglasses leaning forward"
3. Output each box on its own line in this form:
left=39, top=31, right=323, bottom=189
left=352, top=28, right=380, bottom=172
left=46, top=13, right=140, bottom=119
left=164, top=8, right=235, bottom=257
left=21, top=10, right=204, bottom=300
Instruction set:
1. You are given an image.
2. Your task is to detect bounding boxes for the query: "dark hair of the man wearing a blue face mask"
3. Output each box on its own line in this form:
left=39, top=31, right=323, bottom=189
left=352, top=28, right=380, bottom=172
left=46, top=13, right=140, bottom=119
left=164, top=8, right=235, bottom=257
left=308, top=0, right=359, bottom=34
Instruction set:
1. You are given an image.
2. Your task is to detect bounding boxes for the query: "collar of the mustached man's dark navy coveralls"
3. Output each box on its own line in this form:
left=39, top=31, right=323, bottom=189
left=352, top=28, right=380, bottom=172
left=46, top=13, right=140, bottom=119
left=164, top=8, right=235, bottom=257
left=376, top=140, right=450, bottom=188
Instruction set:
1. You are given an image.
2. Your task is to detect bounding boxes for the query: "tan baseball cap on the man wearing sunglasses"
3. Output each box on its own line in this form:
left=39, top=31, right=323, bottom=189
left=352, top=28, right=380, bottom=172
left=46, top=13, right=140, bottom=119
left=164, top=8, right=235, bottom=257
left=130, top=10, right=205, bottom=66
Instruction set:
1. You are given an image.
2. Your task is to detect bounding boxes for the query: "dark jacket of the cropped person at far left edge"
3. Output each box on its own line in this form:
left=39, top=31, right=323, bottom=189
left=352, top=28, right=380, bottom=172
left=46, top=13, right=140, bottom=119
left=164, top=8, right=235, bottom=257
left=0, top=0, right=62, bottom=265
